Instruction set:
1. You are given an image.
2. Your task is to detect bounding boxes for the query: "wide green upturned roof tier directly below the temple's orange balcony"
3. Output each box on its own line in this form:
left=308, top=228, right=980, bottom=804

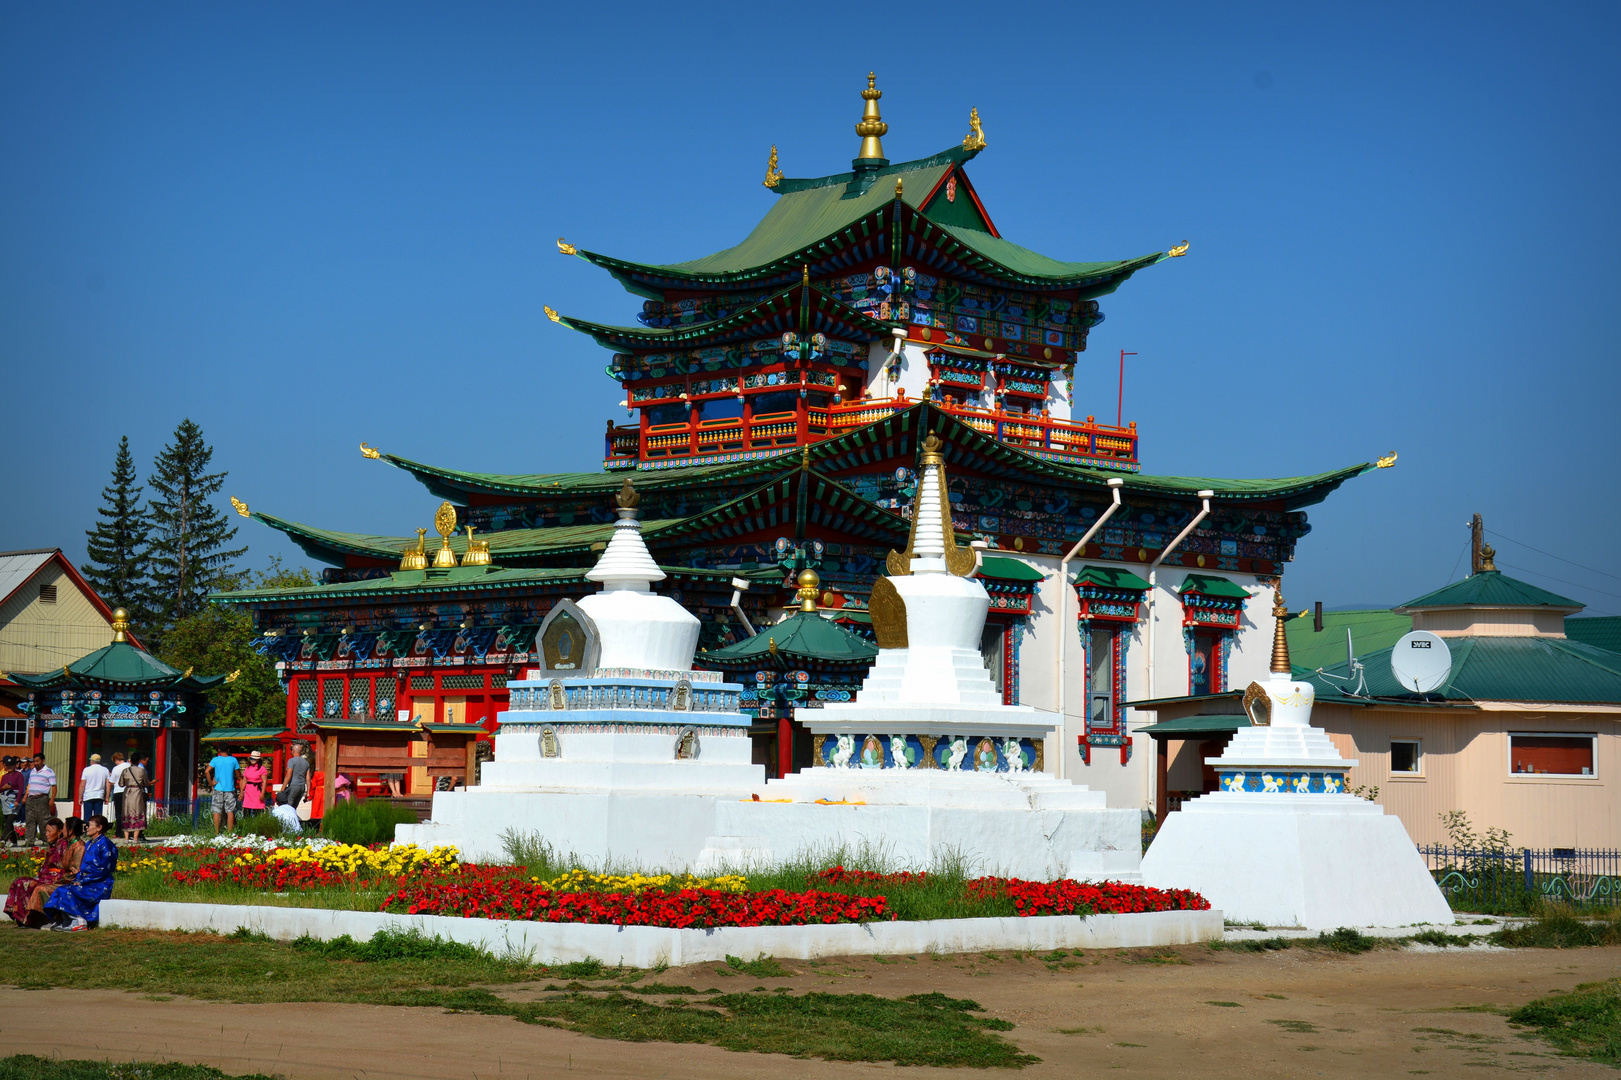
left=364, top=402, right=1375, bottom=509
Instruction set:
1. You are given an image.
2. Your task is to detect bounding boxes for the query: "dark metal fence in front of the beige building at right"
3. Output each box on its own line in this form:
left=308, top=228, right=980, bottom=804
left=1418, top=845, right=1621, bottom=911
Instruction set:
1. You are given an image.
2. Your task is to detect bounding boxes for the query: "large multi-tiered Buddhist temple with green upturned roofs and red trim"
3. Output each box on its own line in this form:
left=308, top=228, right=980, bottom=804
left=216, top=76, right=1394, bottom=808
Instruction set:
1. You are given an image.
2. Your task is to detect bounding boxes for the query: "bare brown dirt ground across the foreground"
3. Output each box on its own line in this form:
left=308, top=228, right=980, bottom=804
left=0, top=947, right=1621, bottom=1080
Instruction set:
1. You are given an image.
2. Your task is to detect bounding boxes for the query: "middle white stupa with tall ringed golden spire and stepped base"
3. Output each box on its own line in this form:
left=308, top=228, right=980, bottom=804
left=700, top=435, right=1141, bottom=881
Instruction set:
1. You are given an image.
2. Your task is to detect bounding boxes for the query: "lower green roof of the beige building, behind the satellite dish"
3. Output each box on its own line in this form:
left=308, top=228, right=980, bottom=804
left=1295, top=632, right=1621, bottom=704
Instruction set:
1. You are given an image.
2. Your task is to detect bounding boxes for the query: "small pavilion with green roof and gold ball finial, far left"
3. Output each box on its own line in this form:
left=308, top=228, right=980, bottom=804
left=8, top=608, right=237, bottom=811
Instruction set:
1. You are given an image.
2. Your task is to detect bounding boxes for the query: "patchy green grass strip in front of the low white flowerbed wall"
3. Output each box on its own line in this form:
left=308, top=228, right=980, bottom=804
left=0, top=931, right=1037, bottom=1080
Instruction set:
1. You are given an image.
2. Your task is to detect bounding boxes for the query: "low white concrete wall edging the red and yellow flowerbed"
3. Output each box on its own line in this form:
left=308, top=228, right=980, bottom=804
left=101, top=900, right=1222, bottom=968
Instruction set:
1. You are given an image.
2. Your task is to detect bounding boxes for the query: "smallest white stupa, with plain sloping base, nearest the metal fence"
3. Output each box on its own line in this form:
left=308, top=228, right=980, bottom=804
left=1143, top=597, right=1452, bottom=929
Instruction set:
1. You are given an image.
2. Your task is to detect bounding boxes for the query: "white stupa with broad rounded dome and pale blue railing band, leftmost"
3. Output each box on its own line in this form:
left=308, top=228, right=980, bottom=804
left=396, top=480, right=765, bottom=869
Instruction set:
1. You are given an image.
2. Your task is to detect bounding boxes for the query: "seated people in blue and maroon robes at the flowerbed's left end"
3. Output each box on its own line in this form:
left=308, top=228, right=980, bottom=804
left=5, top=814, right=118, bottom=931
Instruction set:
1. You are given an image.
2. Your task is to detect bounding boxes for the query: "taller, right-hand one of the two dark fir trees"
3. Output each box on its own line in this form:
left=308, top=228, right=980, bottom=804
left=146, top=420, right=248, bottom=628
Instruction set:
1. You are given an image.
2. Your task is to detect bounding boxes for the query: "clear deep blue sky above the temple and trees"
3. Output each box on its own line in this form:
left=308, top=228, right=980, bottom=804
left=0, top=3, right=1621, bottom=613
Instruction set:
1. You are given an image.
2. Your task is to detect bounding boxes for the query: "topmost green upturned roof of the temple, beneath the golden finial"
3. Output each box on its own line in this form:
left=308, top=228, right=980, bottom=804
left=577, top=148, right=1165, bottom=300
